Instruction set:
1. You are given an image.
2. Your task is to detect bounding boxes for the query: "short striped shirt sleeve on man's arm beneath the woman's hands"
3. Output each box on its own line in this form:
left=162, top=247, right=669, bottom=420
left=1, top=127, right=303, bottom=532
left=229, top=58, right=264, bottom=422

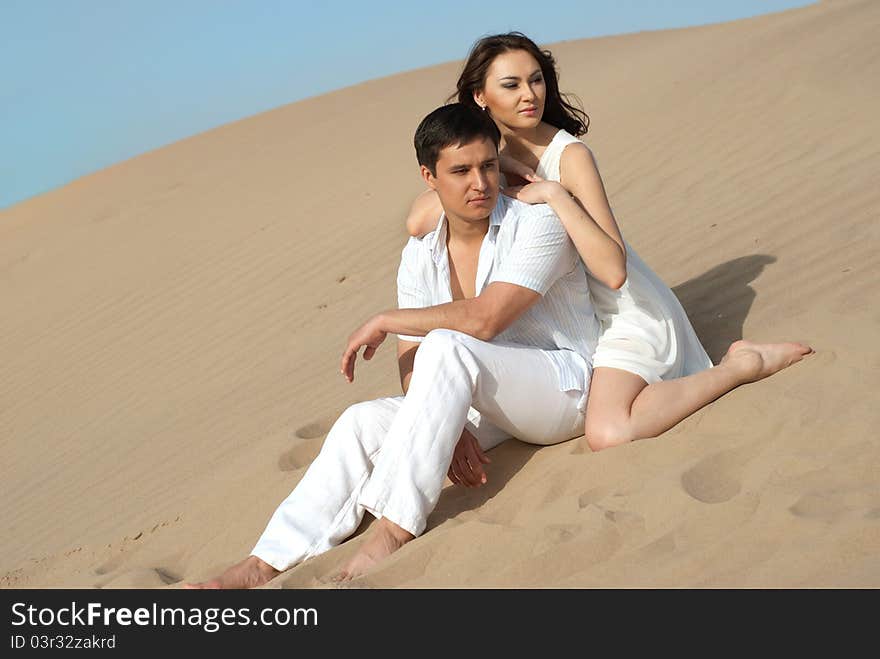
left=492, top=206, right=578, bottom=295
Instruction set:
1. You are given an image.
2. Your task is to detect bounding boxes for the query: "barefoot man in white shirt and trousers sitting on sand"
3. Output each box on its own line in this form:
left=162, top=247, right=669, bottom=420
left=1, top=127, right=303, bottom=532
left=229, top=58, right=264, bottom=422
left=188, top=104, right=599, bottom=588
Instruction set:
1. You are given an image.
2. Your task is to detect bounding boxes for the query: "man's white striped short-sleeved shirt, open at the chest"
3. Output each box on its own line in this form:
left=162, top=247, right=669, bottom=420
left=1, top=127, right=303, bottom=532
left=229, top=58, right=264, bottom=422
left=397, top=194, right=599, bottom=403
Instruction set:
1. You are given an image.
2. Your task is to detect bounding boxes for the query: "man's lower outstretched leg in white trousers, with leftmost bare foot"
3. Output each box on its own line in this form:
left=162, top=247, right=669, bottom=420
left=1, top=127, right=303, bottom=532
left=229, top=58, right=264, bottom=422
left=189, top=396, right=403, bottom=588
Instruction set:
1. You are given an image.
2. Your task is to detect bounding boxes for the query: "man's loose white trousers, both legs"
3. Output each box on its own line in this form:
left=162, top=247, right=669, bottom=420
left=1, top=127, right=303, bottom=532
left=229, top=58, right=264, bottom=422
left=251, top=330, right=590, bottom=570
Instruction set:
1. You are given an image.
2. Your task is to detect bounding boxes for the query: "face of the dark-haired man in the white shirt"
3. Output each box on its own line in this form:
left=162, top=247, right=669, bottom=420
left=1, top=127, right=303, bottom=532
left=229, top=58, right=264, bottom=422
left=422, top=138, right=499, bottom=222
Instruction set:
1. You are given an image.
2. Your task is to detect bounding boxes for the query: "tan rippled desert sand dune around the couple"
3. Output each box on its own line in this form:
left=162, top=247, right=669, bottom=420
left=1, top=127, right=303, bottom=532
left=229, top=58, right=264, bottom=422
left=0, top=0, right=880, bottom=588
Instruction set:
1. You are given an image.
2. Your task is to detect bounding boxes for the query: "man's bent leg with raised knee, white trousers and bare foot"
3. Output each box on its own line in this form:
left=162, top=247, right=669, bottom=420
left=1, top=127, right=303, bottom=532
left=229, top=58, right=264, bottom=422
left=342, top=330, right=589, bottom=577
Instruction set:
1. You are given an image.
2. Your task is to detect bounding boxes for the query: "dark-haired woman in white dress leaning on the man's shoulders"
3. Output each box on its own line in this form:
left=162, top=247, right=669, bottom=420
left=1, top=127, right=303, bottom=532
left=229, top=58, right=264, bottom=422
left=407, top=32, right=812, bottom=456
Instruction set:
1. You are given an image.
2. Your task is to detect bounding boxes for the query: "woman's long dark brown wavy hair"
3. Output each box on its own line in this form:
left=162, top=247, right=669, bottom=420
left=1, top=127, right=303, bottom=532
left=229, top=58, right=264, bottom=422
left=449, top=32, right=590, bottom=137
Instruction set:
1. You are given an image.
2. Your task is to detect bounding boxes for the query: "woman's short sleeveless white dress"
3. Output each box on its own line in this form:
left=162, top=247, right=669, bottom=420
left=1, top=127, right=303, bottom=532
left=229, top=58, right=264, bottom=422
left=535, top=130, right=712, bottom=384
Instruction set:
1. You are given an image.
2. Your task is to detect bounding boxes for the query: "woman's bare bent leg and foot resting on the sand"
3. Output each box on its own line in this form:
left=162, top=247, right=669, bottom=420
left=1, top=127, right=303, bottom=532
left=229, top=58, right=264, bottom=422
left=584, top=341, right=813, bottom=451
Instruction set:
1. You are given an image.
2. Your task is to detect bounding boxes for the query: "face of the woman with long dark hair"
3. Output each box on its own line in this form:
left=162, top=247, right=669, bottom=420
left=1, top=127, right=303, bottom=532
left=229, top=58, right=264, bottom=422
left=474, top=50, right=547, bottom=130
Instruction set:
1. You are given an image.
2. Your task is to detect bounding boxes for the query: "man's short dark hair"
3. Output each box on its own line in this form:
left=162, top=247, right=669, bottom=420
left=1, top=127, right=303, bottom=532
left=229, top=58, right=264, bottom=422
left=413, top=103, right=501, bottom=176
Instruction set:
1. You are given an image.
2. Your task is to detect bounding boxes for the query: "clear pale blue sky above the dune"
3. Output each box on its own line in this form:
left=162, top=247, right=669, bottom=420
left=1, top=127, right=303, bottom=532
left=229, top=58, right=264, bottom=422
left=0, top=0, right=810, bottom=209
